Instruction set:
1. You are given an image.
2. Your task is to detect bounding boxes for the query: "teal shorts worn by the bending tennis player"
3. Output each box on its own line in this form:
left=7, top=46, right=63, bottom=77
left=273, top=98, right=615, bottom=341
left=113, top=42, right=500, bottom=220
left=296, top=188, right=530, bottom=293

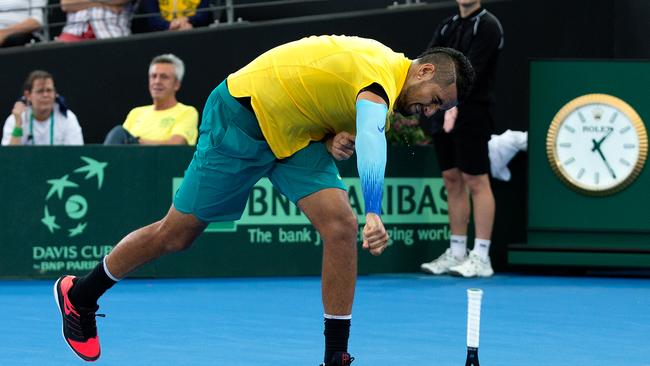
left=174, top=81, right=345, bottom=222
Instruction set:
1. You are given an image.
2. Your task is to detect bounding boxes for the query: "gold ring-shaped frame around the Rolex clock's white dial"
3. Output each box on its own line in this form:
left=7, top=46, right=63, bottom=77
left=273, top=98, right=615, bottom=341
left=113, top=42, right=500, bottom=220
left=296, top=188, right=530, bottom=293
left=546, top=94, right=648, bottom=196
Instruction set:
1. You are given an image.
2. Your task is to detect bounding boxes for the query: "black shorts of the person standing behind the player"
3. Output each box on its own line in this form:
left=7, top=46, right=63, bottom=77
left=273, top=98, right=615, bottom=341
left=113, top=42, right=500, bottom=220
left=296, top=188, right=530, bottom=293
left=433, top=104, right=492, bottom=175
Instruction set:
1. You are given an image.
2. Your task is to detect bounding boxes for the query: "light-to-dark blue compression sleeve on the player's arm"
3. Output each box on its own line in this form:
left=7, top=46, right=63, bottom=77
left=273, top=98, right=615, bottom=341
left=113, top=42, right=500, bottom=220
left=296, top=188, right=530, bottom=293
left=355, top=99, right=388, bottom=215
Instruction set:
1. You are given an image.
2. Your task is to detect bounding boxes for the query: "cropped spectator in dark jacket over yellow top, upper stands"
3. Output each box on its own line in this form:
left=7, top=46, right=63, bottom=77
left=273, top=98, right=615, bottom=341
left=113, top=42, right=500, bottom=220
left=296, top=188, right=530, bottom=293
left=140, top=0, right=212, bottom=31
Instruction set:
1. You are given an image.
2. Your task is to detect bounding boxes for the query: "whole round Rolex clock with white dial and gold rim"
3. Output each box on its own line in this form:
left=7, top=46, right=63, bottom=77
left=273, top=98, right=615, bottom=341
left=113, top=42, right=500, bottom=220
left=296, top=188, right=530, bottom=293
left=546, top=94, right=648, bottom=195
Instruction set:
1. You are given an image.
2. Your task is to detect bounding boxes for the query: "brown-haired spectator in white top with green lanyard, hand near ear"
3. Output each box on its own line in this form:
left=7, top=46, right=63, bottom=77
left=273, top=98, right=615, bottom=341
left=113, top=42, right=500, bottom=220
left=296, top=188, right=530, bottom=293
left=2, top=70, right=83, bottom=145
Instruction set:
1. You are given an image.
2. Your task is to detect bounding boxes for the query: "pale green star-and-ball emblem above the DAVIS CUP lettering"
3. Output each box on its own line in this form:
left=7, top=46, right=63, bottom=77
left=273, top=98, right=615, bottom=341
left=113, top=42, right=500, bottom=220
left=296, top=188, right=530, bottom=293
left=41, top=156, right=108, bottom=238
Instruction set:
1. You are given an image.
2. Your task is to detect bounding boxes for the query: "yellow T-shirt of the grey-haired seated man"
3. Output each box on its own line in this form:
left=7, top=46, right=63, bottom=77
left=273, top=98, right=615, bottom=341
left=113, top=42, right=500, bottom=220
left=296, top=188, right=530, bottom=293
left=122, top=103, right=199, bottom=145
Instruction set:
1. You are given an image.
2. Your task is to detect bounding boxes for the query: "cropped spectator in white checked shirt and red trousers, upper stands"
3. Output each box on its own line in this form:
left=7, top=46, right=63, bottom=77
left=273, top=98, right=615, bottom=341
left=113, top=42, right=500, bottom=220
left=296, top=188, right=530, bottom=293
left=57, top=0, right=133, bottom=42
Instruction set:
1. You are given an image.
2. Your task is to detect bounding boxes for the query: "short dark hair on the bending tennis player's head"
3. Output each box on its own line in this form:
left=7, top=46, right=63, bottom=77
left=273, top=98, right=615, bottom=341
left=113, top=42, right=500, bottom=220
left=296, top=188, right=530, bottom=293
left=418, top=47, right=475, bottom=103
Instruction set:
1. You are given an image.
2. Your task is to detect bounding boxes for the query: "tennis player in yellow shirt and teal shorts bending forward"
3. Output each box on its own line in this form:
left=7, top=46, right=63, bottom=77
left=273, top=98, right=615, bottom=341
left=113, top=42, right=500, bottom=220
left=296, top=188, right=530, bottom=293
left=54, top=36, right=474, bottom=366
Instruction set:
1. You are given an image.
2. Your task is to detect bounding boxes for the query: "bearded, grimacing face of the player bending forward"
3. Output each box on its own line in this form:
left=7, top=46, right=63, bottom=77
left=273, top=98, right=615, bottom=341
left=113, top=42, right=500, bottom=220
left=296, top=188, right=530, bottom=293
left=396, top=80, right=457, bottom=117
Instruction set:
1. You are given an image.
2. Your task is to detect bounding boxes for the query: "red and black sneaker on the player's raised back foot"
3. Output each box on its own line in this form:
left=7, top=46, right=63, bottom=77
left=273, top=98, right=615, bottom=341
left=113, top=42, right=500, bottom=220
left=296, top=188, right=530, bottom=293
left=54, top=276, right=104, bottom=362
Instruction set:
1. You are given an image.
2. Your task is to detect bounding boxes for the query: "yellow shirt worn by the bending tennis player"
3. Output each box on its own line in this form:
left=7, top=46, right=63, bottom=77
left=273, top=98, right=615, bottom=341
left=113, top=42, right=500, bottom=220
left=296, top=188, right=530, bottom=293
left=228, top=36, right=411, bottom=159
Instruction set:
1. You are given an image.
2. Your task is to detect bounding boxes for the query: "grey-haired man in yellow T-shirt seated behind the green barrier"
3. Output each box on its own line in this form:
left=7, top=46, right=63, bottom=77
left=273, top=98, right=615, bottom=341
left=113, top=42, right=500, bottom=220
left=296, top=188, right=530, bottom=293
left=104, top=54, right=199, bottom=145
